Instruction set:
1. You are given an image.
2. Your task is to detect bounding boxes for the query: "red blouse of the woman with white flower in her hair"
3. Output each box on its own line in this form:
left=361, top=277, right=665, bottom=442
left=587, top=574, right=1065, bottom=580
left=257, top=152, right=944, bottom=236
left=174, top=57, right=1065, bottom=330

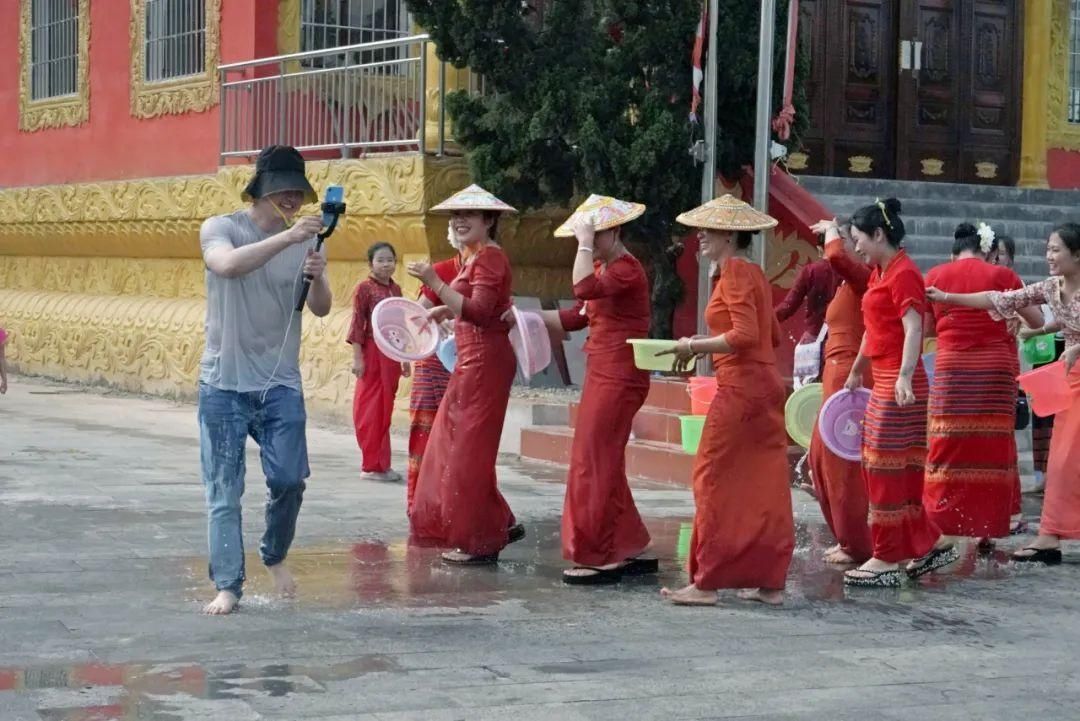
left=927, top=258, right=1024, bottom=351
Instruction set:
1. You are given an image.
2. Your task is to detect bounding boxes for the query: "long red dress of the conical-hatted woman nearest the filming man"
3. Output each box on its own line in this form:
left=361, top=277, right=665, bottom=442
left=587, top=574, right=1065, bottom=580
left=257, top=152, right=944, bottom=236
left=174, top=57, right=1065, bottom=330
left=409, top=246, right=515, bottom=556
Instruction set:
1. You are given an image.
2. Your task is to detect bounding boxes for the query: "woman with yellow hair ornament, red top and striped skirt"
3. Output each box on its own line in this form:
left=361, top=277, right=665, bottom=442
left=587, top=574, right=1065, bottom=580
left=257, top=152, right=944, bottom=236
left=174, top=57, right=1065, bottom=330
left=843, top=198, right=959, bottom=586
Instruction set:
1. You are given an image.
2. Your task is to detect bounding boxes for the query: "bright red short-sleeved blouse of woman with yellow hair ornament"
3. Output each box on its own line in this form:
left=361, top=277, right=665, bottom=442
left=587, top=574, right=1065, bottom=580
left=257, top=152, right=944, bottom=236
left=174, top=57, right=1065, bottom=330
left=863, top=250, right=927, bottom=359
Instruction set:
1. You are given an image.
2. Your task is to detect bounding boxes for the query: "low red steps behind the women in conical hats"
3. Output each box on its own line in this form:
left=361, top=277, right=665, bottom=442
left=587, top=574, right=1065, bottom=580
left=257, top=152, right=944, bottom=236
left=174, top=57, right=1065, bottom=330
left=521, top=378, right=805, bottom=487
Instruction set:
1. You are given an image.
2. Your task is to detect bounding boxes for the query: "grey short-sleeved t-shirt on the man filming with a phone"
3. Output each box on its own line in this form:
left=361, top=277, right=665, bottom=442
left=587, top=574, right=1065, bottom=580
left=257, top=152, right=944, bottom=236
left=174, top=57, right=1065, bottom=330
left=199, top=210, right=315, bottom=393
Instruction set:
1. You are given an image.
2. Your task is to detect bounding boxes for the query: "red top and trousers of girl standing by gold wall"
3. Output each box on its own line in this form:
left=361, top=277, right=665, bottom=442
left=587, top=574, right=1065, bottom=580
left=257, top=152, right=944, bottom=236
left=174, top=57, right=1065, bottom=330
left=347, top=276, right=402, bottom=473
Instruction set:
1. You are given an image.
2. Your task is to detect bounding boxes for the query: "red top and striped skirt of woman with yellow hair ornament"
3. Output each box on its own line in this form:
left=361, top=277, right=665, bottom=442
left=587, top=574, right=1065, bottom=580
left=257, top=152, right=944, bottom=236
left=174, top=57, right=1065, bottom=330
left=863, top=250, right=941, bottom=563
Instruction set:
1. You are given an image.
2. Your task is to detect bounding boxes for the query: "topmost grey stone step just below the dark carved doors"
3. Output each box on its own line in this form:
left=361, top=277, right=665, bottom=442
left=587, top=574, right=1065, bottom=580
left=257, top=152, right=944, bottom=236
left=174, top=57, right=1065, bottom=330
left=798, top=176, right=1080, bottom=207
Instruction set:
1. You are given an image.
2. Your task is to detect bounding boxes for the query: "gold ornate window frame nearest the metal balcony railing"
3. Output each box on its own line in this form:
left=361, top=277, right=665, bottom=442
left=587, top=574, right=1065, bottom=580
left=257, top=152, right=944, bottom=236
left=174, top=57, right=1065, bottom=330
left=131, top=0, right=221, bottom=118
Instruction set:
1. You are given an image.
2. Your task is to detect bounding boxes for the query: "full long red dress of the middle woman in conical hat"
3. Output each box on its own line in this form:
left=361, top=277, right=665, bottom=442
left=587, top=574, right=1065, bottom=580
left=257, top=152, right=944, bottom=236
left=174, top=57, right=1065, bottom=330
left=559, top=254, right=650, bottom=567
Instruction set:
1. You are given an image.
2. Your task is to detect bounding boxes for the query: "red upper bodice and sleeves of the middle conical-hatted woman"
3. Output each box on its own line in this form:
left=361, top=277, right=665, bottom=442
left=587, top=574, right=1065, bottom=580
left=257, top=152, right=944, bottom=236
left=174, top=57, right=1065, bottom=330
left=558, top=254, right=652, bottom=354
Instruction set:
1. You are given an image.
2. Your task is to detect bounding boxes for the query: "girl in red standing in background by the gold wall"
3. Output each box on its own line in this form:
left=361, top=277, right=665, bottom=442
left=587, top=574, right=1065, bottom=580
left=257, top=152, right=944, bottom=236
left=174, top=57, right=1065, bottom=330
left=346, top=243, right=409, bottom=481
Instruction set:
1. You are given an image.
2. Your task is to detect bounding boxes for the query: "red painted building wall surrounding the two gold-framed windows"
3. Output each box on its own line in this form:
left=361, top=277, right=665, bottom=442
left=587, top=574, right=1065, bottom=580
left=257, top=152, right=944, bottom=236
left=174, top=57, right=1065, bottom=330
left=0, top=0, right=278, bottom=187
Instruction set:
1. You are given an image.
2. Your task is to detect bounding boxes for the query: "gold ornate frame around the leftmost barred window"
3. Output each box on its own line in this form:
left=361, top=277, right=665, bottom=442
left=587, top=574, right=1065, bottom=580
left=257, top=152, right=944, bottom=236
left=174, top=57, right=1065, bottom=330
left=18, top=0, right=90, bottom=132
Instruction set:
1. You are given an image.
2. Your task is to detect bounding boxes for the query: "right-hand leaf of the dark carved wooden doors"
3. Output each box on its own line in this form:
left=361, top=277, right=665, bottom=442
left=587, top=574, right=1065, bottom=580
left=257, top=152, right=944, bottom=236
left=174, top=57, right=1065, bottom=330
left=896, top=0, right=1023, bottom=185
